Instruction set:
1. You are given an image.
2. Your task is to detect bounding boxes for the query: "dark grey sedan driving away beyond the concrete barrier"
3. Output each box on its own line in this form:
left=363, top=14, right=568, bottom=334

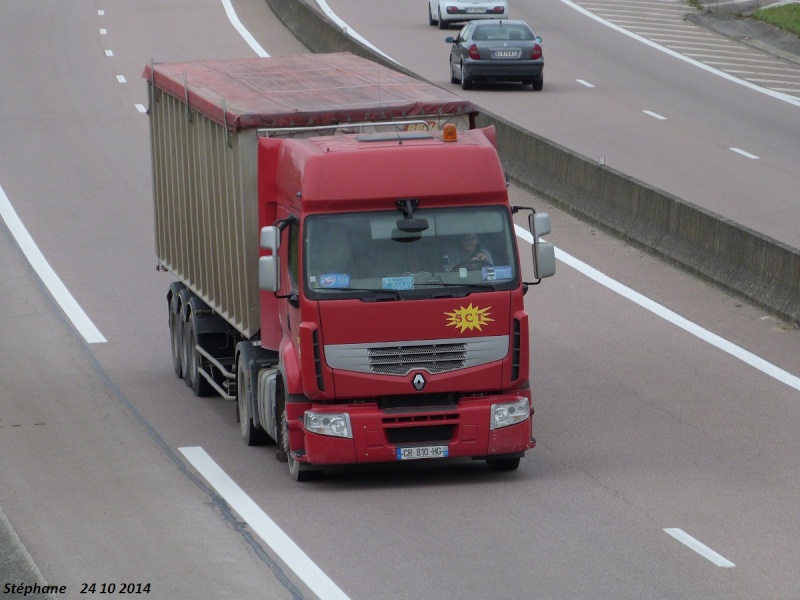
left=445, top=20, right=544, bottom=91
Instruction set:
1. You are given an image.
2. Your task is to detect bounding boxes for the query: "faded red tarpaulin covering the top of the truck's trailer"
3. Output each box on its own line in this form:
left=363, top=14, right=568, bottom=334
left=142, top=52, right=476, bottom=131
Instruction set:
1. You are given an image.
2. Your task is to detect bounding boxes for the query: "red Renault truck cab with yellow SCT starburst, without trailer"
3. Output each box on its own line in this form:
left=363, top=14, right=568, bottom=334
left=259, top=125, right=551, bottom=475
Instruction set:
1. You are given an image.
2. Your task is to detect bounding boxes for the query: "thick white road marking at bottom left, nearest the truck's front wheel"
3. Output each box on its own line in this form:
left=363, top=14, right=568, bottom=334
left=178, top=446, right=349, bottom=600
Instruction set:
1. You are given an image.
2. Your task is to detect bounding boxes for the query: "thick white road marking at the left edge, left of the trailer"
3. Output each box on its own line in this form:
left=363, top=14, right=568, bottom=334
left=0, top=186, right=106, bottom=344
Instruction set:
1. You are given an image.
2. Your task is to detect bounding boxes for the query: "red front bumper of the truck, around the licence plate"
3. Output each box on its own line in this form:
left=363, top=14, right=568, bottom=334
left=290, top=394, right=536, bottom=465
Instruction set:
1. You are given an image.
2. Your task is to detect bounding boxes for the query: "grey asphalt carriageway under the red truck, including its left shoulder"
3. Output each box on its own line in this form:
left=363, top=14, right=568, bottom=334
left=0, top=0, right=800, bottom=598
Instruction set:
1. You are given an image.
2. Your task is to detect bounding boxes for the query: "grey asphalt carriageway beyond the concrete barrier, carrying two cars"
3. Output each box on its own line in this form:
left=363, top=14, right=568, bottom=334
left=328, top=0, right=800, bottom=248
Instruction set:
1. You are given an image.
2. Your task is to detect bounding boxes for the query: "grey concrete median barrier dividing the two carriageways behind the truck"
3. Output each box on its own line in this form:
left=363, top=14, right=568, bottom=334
left=266, top=0, right=800, bottom=324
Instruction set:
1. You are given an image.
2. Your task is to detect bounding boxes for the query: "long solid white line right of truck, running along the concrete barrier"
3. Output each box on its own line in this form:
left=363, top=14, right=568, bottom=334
left=515, top=225, right=800, bottom=391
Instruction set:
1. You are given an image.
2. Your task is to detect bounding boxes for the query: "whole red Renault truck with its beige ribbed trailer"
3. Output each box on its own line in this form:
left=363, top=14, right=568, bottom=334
left=144, top=53, right=555, bottom=480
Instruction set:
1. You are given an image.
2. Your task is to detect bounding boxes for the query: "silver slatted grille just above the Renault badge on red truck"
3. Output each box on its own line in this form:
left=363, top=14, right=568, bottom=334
left=367, top=344, right=467, bottom=375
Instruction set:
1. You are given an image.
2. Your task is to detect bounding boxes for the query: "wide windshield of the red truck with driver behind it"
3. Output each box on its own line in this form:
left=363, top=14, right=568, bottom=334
left=303, top=206, right=519, bottom=301
